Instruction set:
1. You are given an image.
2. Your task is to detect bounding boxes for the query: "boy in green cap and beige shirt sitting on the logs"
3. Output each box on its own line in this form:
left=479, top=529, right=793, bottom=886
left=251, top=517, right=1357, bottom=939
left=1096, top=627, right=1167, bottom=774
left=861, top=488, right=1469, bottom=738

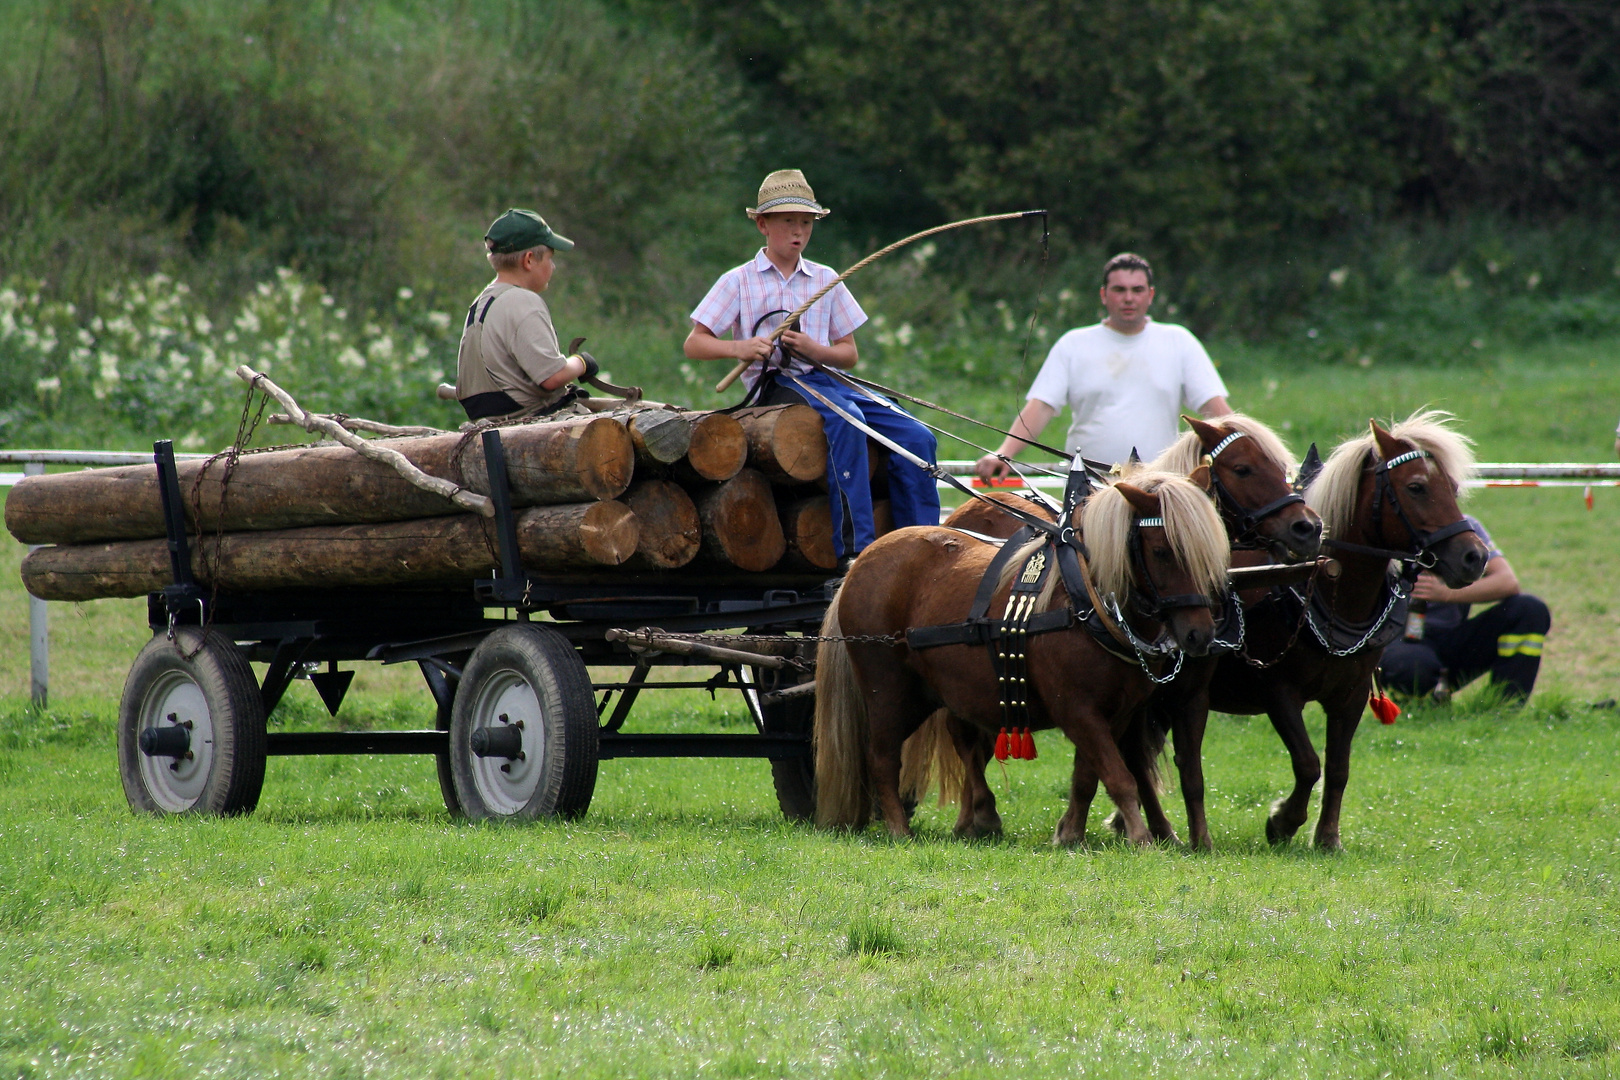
left=455, top=210, right=596, bottom=419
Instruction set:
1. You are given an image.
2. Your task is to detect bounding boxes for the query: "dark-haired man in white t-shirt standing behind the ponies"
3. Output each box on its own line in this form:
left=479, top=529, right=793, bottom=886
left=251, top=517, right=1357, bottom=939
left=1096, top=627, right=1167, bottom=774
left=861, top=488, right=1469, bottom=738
left=975, top=253, right=1231, bottom=481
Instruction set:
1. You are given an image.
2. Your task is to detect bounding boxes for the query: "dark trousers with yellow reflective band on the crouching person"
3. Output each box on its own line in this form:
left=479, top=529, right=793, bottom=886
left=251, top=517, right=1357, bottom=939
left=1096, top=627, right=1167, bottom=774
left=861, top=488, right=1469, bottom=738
left=1379, top=593, right=1552, bottom=698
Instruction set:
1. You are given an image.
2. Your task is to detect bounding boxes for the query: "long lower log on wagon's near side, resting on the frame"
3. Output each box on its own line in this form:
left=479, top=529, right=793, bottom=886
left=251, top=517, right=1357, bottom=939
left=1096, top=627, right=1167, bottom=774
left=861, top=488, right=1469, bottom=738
left=23, top=502, right=640, bottom=601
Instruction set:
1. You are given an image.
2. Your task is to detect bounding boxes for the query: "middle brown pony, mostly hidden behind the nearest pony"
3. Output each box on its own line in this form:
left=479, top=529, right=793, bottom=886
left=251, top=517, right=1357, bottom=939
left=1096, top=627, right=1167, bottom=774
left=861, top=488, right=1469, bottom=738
left=933, top=413, right=1322, bottom=848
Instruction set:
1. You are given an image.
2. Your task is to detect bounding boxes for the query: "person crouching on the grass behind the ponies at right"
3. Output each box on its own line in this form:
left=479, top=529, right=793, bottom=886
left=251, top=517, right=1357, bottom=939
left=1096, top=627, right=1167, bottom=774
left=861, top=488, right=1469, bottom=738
left=1379, top=517, right=1552, bottom=701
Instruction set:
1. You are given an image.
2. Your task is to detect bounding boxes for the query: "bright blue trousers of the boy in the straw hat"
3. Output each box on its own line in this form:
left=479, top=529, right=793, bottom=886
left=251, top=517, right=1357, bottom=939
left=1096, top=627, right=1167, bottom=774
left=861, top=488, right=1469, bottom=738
left=782, top=371, right=940, bottom=559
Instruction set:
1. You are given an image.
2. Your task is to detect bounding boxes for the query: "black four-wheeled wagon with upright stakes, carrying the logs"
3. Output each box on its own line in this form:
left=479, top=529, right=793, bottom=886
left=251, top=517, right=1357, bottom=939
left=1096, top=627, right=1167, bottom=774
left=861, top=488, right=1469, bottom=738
left=118, top=431, right=838, bottom=819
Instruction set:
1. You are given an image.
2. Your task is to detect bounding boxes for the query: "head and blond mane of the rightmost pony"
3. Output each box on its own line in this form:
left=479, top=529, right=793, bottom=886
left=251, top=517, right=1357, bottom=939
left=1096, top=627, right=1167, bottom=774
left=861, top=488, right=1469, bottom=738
left=1306, top=410, right=1487, bottom=589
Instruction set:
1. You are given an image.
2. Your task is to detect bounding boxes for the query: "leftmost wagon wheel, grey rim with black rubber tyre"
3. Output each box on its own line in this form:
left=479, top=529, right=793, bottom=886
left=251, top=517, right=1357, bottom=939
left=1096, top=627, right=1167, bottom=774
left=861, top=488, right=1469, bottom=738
left=118, top=627, right=266, bottom=814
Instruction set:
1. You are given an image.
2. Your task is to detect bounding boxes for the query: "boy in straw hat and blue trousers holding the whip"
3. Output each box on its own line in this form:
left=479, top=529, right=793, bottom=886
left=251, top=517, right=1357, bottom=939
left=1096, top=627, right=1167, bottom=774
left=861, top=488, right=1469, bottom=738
left=684, top=168, right=940, bottom=560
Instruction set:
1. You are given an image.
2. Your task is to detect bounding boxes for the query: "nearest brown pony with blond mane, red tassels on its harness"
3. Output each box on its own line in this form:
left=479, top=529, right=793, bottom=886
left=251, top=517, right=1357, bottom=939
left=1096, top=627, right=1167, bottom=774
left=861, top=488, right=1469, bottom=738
left=815, top=471, right=1228, bottom=844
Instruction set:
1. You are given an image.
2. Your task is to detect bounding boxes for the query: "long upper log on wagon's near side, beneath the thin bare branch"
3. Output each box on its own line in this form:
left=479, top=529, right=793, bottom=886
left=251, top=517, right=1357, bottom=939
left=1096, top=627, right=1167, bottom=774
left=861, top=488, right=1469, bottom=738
left=5, top=416, right=635, bottom=544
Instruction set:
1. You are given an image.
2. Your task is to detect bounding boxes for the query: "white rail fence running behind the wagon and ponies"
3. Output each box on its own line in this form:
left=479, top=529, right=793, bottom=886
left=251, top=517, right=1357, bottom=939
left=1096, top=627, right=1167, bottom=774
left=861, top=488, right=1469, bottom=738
left=0, top=450, right=1620, bottom=708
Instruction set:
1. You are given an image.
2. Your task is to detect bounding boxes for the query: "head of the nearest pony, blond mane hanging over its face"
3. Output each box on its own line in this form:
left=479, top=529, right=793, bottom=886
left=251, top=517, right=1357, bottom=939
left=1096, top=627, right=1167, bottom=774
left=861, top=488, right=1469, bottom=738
left=1081, top=468, right=1231, bottom=656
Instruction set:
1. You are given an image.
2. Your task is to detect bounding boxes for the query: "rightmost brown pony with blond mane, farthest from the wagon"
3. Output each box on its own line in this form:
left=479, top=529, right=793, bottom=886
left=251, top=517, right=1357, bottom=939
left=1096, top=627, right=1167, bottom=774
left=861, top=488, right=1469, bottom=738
left=1209, top=411, right=1486, bottom=850
